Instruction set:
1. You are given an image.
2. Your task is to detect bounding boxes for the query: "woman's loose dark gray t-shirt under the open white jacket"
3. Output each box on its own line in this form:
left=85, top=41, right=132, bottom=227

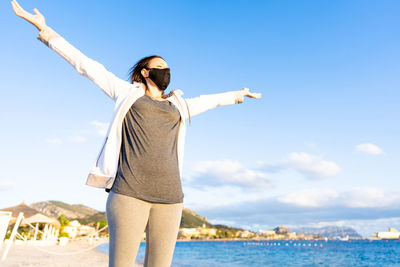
left=111, top=94, right=183, bottom=203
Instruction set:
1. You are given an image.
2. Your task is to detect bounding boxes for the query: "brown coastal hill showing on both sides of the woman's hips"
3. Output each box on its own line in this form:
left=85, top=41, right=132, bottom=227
left=31, top=200, right=225, bottom=229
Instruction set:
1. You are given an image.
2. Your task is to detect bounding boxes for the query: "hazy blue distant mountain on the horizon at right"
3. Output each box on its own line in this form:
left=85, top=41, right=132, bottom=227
left=290, top=226, right=361, bottom=238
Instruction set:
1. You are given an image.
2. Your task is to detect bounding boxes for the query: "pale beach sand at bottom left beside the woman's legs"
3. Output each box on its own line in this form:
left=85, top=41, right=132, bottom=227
left=0, top=241, right=143, bottom=267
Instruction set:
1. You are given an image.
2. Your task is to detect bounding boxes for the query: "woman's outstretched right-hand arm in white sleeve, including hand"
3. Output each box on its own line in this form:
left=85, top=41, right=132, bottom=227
left=185, top=88, right=261, bottom=117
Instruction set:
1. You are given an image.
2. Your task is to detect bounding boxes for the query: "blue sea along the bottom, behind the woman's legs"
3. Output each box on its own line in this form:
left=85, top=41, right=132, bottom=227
left=98, top=240, right=400, bottom=267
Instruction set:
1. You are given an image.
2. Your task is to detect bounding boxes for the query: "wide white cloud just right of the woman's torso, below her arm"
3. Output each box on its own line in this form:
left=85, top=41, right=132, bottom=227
left=187, top=160, right=270, bottom=188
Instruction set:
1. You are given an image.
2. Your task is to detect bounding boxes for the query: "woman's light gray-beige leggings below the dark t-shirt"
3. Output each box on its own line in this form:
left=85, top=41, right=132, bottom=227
left=106, top=191, right=183, bottom=267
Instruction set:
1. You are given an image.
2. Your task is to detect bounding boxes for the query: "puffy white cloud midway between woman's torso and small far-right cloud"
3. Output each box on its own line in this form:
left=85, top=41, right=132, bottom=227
left=286, top=152, right=340, bottom=178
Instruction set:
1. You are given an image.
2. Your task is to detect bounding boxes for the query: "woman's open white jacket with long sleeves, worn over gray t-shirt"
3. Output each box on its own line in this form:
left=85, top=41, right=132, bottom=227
left=37, top=26, right=243, bottom=189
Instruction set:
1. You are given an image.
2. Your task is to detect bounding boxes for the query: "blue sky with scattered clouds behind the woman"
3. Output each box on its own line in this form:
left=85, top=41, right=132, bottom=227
left=0, top=0, right=400, bottom=236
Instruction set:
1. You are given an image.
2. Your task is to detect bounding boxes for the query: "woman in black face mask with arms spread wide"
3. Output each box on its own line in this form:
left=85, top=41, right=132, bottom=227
left=11, top=0, right=261, bottom=267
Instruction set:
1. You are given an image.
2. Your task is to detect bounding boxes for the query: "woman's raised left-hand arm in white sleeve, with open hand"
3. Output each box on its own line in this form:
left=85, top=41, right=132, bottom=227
left=11, top=0, right=132, bottom=100
